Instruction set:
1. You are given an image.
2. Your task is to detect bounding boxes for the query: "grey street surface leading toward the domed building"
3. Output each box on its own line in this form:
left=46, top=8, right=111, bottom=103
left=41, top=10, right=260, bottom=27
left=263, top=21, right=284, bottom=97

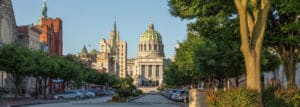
left=27, top=95, right=185, bottom=107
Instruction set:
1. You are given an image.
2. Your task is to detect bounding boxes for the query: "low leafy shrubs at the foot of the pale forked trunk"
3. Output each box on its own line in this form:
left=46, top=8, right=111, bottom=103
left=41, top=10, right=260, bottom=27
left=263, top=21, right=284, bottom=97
left=206, top=87, right=300, bottom=107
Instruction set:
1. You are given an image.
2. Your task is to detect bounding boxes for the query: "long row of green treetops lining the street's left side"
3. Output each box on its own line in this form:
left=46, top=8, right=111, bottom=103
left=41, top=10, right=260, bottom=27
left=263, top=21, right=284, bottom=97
left=0, top=44, right=125, bottom=95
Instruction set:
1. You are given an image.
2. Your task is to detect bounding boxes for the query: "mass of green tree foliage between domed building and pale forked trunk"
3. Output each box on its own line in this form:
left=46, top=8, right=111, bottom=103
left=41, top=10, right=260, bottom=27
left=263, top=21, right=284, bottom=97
left=165, top=0, right=251, bottom=86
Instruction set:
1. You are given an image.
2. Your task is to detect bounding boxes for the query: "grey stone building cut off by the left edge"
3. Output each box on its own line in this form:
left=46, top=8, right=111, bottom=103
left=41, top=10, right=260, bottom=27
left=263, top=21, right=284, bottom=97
left=0, top=0, right=17, bottom=45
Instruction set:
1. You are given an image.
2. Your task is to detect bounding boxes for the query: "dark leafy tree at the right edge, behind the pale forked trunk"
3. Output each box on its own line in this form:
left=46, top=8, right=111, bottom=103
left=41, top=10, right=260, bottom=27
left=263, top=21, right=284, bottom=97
left=266, top=0, right=300, bottom=88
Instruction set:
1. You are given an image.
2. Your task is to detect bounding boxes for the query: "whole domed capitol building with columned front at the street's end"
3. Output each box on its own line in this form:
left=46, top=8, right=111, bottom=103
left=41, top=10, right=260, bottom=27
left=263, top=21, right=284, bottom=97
left=127, top=19, right=168, bottom=87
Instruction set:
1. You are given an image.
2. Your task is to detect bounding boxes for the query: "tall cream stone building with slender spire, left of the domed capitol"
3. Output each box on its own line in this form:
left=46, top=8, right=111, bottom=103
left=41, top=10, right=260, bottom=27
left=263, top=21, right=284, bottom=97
left=96, top=21, right=127, bottom=78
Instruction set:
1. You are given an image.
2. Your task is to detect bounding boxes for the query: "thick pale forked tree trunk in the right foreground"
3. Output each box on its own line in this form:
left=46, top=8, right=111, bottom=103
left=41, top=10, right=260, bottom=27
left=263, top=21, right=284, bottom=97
left=234, top=0, right=270, bottom=106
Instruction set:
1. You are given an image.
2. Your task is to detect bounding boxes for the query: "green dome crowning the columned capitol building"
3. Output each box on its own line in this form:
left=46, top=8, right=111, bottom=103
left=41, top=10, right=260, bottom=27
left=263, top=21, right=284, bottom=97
left=140, top=23, right=162, bottom=42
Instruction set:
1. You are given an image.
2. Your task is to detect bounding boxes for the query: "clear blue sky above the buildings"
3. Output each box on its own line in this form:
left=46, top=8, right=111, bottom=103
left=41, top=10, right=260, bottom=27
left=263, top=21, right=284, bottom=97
left=12, top=0, right=189, bottom=58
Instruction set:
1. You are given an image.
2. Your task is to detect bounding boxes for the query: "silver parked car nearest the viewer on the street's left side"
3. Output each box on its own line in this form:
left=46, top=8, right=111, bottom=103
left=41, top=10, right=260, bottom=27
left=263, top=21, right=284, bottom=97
left=54, top=91, right=85, bottom=100
